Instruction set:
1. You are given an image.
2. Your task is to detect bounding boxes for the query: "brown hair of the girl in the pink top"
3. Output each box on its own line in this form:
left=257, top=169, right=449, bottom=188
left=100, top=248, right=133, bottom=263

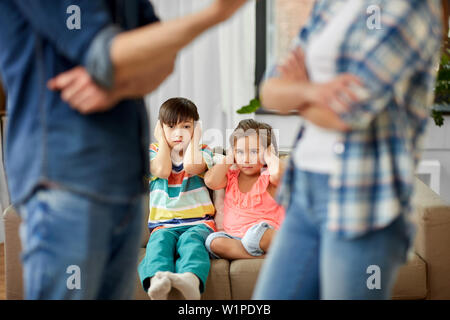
left=230, top=119, right=278, bottom=152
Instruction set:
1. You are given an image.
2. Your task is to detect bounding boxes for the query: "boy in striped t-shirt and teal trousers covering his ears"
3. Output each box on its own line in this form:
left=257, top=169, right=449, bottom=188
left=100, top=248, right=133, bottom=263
left=138, top=98, right=215, bottom=300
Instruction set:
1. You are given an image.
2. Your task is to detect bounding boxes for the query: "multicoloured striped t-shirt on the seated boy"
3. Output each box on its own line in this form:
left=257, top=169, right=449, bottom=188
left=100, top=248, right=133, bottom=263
left=148, top=143, right=216, bottom=232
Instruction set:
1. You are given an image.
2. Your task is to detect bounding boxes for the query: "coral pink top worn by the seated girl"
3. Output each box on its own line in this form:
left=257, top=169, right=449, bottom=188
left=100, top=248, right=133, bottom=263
left=223, top=169, right=285, bottom=238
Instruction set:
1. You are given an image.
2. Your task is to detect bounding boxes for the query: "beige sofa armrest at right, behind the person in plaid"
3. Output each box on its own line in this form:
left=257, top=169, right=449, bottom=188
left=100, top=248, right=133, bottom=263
left=413, top=180, right=450, bottom=299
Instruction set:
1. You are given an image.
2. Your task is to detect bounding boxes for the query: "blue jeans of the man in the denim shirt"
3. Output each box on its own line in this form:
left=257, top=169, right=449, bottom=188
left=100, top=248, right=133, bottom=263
left=19, top=189, right=143, bottom=299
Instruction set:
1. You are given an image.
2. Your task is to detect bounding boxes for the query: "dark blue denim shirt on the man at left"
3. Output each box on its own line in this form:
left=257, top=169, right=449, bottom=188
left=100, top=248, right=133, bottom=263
left=0, top=0, right=158, bottom=204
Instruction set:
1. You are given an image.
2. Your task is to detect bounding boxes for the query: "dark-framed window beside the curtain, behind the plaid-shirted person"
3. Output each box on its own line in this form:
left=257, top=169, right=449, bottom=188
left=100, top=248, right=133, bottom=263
left=255, top=0, right=314, bottom=114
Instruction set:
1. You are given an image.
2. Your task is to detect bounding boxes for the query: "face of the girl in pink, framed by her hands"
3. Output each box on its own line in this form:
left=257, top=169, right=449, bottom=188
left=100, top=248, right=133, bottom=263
left=234, top=134, right=264, bottom=175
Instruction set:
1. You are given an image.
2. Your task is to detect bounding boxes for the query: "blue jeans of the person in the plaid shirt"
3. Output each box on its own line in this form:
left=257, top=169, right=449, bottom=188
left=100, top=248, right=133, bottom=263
left=253, top=168, right=410, bottom=300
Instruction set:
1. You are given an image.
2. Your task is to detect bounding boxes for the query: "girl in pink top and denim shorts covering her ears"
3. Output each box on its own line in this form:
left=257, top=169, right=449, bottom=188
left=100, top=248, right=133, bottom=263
left=205, top=119, right=284, bottom=260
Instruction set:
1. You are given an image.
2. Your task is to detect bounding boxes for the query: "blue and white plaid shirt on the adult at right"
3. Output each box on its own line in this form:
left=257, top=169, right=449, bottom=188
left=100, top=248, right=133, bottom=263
left=278, top=0, right=442, bottom=238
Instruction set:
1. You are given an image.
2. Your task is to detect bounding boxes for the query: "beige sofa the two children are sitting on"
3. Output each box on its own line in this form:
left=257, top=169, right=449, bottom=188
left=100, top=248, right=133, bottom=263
left=3, top=180, right=450, bottom=300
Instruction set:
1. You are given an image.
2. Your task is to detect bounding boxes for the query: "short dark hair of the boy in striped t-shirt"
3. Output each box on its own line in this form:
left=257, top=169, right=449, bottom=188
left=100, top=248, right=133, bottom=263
left=158, top=97, right=200, bottom=126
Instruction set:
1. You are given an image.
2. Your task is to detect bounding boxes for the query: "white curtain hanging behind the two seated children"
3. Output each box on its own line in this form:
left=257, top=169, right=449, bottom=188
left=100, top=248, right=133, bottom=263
left=146, top=0, right=255, bottom=147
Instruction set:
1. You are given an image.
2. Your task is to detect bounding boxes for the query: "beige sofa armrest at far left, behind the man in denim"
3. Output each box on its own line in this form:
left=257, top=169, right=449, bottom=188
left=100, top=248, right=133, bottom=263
left=3, top=206, right=23, bottom=300
